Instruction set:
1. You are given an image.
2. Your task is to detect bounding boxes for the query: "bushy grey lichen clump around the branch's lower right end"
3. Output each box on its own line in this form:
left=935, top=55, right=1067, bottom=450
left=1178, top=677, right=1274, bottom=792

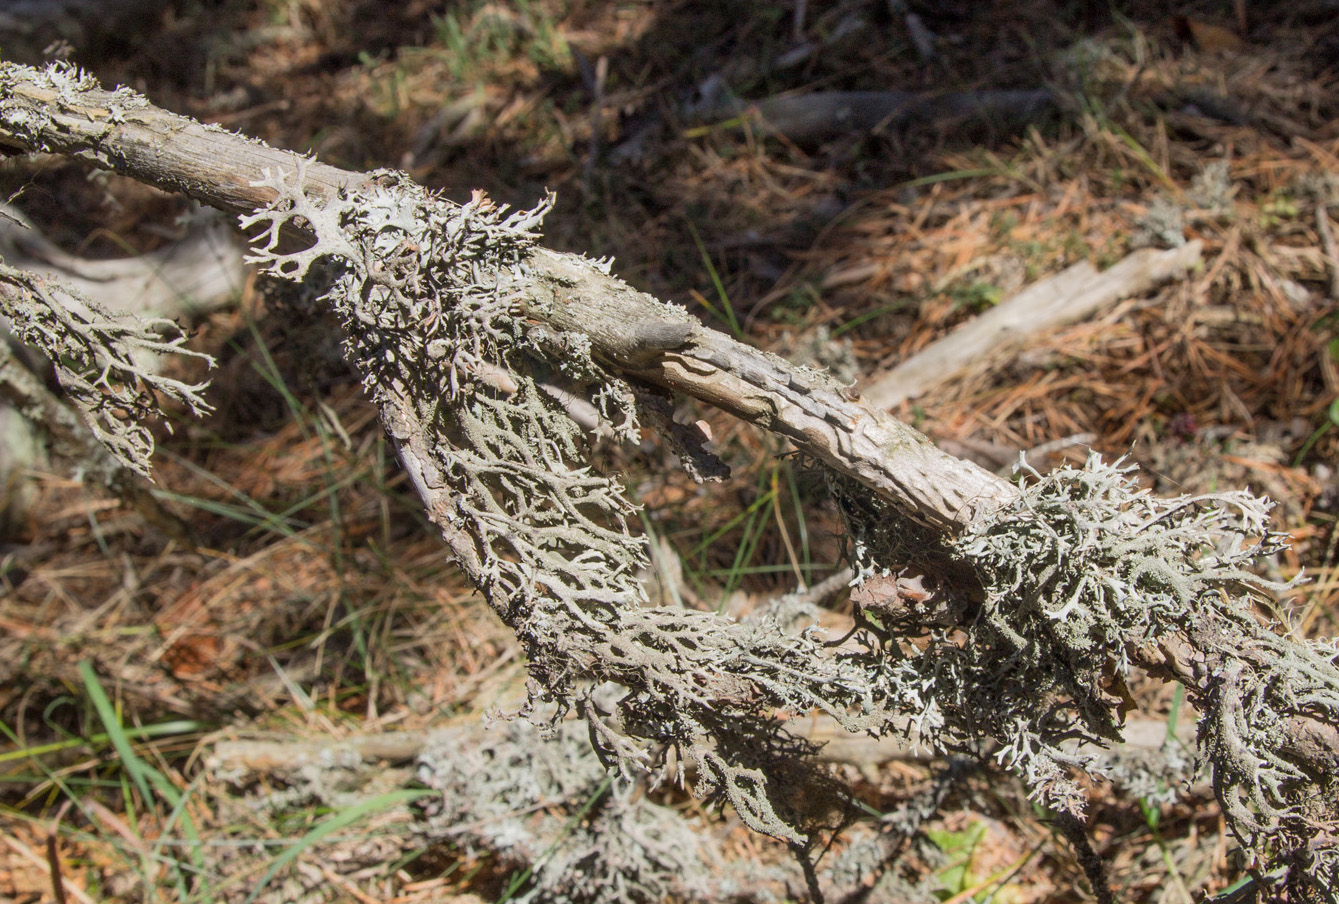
left=853, top=457, right=1339, bottom=900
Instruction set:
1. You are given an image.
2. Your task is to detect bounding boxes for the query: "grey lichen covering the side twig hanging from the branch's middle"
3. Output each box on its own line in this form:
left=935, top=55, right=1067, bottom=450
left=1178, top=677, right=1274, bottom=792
left=242, top=166, right=872, bottom=844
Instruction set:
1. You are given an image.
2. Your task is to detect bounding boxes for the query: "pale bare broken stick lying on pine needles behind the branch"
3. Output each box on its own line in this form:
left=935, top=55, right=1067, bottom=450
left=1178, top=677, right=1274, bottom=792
left=864, top=241, right=1202, bottom=408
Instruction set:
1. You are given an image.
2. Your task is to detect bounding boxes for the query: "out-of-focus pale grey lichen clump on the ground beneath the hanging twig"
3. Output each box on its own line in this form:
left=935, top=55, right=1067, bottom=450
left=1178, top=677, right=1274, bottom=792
left=416, top=722, right=744, bottom=904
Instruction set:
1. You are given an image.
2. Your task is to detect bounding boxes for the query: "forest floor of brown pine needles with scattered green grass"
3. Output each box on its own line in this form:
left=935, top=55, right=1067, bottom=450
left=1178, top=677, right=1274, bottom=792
left=0, top=0, right=1339, bottom=903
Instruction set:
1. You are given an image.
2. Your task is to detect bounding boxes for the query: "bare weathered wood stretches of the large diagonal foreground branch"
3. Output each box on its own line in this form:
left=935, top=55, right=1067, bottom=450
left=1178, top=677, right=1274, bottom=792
left=0, top=64, right=1015, bottom=533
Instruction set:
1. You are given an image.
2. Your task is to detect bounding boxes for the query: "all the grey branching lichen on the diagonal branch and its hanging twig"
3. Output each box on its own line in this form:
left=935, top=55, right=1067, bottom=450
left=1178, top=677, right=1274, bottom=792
left=232, top=159, right=1339, bottom=881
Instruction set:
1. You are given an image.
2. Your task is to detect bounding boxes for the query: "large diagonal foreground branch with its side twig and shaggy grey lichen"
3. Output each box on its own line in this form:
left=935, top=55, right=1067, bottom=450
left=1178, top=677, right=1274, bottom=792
left=0, top=64, right=1339, bottom=897
